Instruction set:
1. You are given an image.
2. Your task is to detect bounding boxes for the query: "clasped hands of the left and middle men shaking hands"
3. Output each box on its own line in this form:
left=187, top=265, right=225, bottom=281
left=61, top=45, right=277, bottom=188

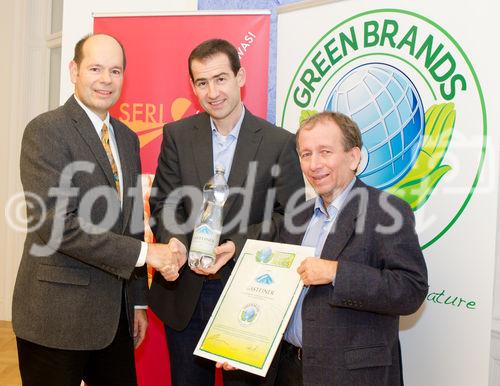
left=146, top=237, right=187, bottom=281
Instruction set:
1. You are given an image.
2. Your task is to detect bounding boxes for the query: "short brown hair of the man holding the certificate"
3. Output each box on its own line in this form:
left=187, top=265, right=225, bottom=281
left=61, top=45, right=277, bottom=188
left=295, top=111, right=363, bottom=151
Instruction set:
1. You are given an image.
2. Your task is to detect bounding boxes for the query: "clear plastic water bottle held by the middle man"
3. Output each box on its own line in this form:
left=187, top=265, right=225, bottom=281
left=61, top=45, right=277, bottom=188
left=188, top=166, right=229, bottom=268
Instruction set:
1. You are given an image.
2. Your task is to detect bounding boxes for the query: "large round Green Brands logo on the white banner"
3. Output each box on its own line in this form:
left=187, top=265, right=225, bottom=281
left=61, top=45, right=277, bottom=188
left=278, top=9, right=487, bottom=249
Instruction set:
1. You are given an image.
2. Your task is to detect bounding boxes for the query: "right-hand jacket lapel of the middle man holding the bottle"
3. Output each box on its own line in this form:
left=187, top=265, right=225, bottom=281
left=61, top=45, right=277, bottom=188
left=224, top=109, right=262, bottom=216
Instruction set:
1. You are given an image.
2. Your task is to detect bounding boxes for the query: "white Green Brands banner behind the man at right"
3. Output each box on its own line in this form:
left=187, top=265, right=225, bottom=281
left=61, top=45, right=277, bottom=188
left=276, top=0, right=498, bottom=386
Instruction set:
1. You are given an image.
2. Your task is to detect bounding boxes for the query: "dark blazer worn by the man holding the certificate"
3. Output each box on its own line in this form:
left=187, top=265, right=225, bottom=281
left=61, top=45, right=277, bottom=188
left=280, top=180, right=428, bottom=386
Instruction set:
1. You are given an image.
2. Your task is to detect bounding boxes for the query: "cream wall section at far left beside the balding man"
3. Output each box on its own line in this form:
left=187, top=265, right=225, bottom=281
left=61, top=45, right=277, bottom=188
left=0, top=0, right=54, bottom=320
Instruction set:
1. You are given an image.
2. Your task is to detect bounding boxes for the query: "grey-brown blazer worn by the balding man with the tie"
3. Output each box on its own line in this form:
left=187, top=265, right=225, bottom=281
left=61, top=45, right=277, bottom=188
left=12, top=97, right=147, bottom=350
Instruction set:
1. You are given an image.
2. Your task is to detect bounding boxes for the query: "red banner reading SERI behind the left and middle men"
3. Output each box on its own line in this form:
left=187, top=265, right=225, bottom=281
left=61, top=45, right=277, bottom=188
left=94, top=14, right=270, bottom=386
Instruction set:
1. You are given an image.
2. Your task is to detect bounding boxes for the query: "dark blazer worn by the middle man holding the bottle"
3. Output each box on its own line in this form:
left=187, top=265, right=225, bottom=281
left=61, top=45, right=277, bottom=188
left=149, top=109, right=304, bottom=330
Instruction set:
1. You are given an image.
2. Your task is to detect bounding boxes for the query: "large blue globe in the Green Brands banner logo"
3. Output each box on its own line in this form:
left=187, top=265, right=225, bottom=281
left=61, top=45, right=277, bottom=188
left=325, top=63, right=425, bottom=189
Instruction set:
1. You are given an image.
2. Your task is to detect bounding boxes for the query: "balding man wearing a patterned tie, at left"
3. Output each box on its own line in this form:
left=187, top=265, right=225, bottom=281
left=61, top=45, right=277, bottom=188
left=12, top=34, right=186, bottom=386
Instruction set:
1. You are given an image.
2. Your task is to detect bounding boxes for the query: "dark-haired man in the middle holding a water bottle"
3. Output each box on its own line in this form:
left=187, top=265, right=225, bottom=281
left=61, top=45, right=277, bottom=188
left=149, top=39, right=304, bottom=386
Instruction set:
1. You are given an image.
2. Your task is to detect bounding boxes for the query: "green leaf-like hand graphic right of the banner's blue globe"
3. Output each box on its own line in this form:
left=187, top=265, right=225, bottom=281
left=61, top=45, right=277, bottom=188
left=387, top=103, right=456, bottom=210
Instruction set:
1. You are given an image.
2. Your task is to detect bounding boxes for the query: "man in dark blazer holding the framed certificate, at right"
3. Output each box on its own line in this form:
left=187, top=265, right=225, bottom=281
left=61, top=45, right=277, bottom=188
left=275, top=112, right=428, bottom=386
